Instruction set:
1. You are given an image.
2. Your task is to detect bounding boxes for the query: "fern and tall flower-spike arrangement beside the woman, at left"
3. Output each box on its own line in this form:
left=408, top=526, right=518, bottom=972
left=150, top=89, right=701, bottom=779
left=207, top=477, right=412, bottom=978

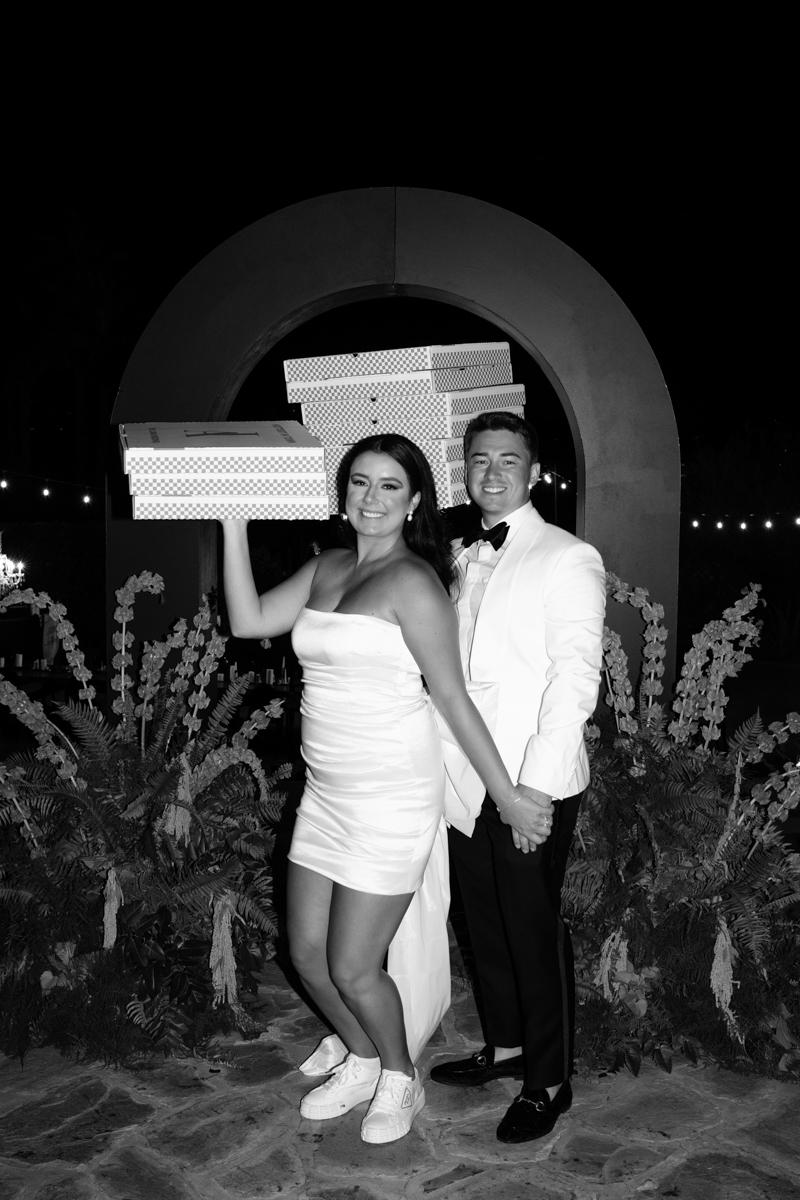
left=0, top=572, right=290, bottom=1060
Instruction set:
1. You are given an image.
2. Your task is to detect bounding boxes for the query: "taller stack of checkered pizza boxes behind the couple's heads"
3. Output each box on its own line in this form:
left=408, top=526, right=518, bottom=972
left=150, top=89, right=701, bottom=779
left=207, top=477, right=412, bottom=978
left=283, top=342, right=525, bottom=512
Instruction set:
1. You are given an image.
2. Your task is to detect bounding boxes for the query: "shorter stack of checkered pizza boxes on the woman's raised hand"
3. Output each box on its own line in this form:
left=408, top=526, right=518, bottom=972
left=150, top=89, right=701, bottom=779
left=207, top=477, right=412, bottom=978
left=120, top=421, right=329, bottom=521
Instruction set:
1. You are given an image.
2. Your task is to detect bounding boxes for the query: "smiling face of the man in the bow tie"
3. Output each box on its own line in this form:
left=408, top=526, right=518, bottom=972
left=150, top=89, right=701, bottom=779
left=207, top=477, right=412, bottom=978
left=467, top=430, right=541, bottom=526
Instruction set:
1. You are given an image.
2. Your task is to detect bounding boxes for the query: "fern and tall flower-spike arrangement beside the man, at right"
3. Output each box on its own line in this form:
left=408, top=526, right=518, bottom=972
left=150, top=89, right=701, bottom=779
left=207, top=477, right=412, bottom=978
left=565, top=574, right=800, bottom=1074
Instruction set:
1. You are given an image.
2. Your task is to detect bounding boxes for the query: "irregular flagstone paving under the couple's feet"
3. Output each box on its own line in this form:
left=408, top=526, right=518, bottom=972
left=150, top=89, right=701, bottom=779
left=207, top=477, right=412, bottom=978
left=0, top=936, right=800, bottom=1200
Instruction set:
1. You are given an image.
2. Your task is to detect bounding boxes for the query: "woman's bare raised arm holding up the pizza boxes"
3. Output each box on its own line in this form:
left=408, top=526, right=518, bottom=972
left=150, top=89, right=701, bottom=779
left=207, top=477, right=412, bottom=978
left=221, top=520, right=319, bottom=637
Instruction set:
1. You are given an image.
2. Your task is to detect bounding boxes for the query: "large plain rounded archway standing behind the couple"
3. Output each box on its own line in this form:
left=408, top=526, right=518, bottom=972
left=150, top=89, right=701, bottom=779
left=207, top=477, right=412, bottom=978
left=108, top=187, right=680, bottom=676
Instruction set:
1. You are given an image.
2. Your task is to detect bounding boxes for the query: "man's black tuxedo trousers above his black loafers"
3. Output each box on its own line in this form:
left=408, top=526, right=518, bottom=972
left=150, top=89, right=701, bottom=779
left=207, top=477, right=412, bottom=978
left=450, top=793, right=583, bottom=1087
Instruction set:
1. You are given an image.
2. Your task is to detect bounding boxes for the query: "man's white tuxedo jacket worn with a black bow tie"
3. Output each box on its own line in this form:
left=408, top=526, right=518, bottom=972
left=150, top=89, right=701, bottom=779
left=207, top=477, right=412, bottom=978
left=456, top=506, right=606, bottom=832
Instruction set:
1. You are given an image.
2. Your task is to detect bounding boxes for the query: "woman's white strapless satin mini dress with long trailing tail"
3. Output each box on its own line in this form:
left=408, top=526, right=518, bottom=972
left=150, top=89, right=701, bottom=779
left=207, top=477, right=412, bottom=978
left=289, top=608, right=450, bottom=1060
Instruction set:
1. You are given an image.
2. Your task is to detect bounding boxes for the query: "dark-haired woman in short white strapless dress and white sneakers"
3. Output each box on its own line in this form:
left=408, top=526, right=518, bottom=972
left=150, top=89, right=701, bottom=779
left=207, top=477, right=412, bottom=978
left=222, top=434, right=519, bottom=1142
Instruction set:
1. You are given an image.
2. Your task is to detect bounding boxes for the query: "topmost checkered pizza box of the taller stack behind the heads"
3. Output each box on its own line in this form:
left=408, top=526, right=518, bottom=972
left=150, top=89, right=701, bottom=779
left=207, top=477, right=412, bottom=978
left=283, top=342, right=511, bottom=384
